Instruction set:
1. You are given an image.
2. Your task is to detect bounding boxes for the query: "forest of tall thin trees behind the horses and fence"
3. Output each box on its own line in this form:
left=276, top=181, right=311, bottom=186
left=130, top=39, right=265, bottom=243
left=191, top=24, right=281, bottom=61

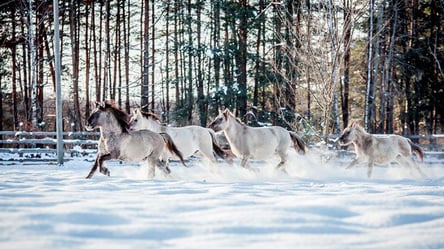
left=0, top=0, right=444, bottom=138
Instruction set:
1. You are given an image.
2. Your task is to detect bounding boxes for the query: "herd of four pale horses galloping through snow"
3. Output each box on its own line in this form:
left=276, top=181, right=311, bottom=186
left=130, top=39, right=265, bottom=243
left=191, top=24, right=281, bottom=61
left=86, top=101, right=425, bottom=178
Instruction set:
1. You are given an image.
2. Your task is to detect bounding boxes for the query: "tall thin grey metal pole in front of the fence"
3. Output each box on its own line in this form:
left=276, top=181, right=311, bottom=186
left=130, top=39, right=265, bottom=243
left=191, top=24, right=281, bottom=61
left=53, top=0, right=64, bottom=166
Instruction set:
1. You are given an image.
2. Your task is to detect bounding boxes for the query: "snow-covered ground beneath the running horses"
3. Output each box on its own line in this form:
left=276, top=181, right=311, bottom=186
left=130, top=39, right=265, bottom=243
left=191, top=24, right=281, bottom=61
left=0, top=152, right=444, bottom=249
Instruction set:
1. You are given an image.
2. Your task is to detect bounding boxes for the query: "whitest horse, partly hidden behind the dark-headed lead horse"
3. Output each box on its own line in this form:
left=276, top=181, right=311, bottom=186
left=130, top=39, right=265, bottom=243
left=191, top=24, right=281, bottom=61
left=129, top=108, right=231, bottom=164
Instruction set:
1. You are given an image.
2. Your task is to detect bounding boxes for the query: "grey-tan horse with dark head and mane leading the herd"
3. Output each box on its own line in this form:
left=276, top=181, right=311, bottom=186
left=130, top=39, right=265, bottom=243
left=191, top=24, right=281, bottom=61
left=86, top=102, right=185, bottom=178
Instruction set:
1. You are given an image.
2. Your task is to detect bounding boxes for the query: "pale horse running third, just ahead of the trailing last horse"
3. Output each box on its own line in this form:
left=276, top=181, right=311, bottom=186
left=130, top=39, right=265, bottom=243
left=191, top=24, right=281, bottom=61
left=208, top=109, right=305, bottom=172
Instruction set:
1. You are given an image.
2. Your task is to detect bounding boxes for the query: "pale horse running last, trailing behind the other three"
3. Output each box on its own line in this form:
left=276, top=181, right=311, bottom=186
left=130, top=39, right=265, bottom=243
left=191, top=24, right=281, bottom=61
left=339, top=122, right=425, bottom=177
